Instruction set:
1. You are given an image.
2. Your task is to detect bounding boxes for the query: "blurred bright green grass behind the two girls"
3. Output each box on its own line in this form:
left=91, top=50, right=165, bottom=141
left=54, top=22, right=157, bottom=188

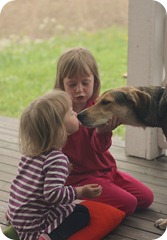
left=0, top=27, right=128, bottom=135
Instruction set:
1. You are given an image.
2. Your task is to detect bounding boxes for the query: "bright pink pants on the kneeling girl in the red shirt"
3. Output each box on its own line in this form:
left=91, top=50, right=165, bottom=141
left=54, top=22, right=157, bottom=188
left=75, top=170, right=154, bottom=215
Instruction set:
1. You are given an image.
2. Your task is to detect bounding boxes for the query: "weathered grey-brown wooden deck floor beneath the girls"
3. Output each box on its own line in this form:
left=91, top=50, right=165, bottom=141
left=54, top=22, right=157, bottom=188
left=0, top=117, right=167, bottom=240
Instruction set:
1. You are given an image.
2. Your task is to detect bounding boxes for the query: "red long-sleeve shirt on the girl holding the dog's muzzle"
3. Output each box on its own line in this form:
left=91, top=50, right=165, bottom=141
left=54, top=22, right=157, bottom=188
left=63, top=102, right=116, bottom=185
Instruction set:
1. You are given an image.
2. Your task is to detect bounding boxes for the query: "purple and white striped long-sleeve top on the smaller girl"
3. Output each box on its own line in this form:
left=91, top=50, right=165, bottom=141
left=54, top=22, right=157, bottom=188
left=7, top=150, right=76, bottom=240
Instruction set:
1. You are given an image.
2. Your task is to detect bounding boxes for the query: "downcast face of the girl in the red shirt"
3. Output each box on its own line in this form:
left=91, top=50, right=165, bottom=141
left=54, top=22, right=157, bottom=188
left=63, top=74, right=94, bottom=109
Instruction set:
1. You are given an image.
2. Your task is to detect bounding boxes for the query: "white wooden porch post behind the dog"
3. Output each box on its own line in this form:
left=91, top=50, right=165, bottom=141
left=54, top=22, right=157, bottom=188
left=125, top=0, right=166, bottom=160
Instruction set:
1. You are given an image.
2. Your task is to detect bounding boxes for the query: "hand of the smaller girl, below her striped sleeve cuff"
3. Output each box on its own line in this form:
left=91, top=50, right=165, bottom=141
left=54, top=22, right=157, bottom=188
left=76, top=184, right=102, bottom=198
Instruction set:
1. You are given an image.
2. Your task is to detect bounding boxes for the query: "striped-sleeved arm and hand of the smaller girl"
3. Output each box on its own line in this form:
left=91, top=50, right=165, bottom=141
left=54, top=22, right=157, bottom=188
left=44, top=156, right=102, bottom=204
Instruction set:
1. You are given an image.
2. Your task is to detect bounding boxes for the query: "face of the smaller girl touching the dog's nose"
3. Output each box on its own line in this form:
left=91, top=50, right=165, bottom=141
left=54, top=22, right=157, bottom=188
left=64, top=107, right=79, bottom=135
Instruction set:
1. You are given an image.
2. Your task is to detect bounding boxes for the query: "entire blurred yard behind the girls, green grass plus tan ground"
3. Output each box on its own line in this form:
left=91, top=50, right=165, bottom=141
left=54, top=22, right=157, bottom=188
left=0, top=0, right=128, bottom=137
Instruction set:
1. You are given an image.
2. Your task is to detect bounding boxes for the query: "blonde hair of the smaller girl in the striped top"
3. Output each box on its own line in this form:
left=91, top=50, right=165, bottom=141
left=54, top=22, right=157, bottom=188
left=19, top=90, right=72, bottom=156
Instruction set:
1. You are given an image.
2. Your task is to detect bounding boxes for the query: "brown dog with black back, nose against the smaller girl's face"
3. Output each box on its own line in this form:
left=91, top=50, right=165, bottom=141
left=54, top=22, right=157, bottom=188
left=77, top=86, right=167, bottom=138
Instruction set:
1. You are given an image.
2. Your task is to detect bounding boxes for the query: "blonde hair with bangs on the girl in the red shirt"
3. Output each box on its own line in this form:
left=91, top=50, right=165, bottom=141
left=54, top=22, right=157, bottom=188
left=54, top=47, right=100, bottom=100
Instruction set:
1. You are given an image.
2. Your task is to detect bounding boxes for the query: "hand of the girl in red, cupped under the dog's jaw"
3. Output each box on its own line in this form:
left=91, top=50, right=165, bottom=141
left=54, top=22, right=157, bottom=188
left=96, top=116, right=121, bottom=134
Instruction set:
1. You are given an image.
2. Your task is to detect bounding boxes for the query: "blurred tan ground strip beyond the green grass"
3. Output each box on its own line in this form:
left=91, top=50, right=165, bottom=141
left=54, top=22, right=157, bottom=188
left=0, top=0, right=128, bottom=39
